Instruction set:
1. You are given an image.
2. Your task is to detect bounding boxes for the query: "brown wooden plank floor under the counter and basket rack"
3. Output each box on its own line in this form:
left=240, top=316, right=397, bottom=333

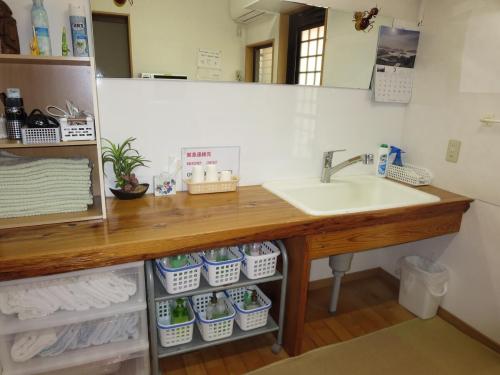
left=161, top=275, right=415, bottom=375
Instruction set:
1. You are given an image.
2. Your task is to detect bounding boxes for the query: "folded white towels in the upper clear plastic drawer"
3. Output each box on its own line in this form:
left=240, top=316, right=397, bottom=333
left=0, top=272, right=137, bottom=320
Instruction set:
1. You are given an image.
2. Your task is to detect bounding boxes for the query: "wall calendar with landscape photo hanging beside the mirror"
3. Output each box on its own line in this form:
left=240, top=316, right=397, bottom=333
left=372, top=26, right=420, bottom=103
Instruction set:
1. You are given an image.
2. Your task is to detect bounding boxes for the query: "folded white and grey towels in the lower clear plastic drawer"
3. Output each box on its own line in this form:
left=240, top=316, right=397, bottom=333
left=10, top=313, right=139, bottom=362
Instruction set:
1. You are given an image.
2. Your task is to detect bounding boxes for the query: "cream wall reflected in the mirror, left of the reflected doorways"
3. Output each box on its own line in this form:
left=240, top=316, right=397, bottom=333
left=92, top=0, right=243, bottom=81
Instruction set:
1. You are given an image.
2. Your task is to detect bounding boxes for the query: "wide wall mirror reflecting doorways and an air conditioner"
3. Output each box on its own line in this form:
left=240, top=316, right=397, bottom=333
left=91, top=0, right=422, bottom=89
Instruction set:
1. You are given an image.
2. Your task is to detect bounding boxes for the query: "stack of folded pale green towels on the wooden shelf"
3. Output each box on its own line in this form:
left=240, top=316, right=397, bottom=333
left=0, top=151, right=93, bottom=218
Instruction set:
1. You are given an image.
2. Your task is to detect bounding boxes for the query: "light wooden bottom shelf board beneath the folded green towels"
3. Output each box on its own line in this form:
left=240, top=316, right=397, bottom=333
left=0, top=197, right=103, bottom=229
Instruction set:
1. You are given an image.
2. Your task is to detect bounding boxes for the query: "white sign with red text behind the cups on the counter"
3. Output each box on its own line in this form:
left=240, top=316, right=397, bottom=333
left=182, top=146, right=240, bottom=190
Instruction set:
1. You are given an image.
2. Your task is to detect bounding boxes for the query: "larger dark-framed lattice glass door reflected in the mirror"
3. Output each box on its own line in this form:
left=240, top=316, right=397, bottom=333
left=286, top=8, right=326, bottom=86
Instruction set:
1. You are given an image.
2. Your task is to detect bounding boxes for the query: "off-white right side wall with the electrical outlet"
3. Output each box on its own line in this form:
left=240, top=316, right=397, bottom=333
left=380, top=0, right=500, bottom=342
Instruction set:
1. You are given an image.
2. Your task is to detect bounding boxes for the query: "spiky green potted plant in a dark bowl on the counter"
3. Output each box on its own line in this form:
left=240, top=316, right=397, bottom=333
left=102, top=137, right=149, bottom=199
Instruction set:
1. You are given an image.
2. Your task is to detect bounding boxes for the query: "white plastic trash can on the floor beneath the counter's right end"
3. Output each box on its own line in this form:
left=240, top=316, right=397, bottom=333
left=399, top=256, right=449, bottom=319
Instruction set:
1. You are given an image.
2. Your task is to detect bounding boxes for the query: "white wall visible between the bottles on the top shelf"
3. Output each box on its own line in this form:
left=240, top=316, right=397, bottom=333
left=4, top=0, right=92, bottom=56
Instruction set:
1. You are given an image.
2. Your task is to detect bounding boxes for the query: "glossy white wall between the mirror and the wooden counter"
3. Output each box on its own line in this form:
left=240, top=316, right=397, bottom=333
left=98, top=79, right=405, bottom=279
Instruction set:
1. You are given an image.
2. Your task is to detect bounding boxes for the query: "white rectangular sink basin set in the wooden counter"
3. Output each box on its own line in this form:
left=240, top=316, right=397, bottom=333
left=263, top=176, right=440, bottom=216
